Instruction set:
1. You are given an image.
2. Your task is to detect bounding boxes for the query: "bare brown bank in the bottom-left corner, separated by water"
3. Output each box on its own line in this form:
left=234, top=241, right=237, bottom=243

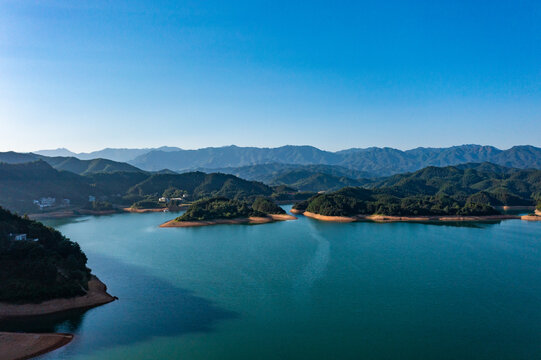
left=0, top=332, right=73, bottom=360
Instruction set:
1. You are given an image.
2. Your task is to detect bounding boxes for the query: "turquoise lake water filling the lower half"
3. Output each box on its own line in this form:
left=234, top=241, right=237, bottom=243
left=0, top=207, right=541, bottom=360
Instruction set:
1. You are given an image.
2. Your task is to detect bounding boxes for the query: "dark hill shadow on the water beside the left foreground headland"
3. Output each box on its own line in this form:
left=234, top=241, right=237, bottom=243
left=0, top=254, right=239, bottom=358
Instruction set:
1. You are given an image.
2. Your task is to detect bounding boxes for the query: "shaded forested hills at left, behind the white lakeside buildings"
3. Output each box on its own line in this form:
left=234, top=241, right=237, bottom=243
left=0, top=160, right=280, bottom=213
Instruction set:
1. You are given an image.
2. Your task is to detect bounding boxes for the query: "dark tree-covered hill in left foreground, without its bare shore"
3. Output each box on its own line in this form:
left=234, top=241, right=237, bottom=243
left=0, top=208, right=90, bottom=303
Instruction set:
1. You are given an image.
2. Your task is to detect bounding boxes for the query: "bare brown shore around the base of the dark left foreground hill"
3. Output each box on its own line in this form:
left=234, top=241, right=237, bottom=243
left=0, top=275, right=118, bottom=320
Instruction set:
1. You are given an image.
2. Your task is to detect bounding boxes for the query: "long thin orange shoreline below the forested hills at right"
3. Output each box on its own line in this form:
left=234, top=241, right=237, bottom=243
left=302, top=211, right=541, bottom=223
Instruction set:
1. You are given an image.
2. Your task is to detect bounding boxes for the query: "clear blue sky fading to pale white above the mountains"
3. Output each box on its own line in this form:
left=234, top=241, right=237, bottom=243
left=0, top=0, right=541, bottom=152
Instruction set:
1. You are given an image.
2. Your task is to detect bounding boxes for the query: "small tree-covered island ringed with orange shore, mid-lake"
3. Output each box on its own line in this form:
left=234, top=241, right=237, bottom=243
left=160, top=197, right=296, bottom=227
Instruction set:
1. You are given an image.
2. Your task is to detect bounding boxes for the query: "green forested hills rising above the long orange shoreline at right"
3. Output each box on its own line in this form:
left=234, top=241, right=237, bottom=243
left=295, top=163, right=541, bottom=216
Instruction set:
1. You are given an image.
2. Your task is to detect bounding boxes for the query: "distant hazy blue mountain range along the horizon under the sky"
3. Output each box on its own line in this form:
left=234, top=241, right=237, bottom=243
left=35, top=145, right=541, bottom=177
